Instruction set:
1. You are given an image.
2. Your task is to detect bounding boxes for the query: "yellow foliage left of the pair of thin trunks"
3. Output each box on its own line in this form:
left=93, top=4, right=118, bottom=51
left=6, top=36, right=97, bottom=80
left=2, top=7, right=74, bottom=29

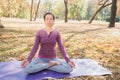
left=0, top=0, right=29, bottom=18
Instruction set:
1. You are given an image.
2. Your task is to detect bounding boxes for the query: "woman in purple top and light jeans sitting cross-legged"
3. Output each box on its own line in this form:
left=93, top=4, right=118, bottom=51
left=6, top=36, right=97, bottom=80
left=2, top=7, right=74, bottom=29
left=22, top=12, right=75, bottom=73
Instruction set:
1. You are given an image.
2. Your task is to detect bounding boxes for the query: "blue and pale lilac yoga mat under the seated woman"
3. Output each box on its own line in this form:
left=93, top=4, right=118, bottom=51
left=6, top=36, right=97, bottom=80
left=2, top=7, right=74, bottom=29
left=0, top=59, right=112, bottom=80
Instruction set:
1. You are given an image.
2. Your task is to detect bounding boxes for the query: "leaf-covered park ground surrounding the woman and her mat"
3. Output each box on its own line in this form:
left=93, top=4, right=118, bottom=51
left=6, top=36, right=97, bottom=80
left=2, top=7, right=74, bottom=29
left=0, top=18, right=120, bottom=80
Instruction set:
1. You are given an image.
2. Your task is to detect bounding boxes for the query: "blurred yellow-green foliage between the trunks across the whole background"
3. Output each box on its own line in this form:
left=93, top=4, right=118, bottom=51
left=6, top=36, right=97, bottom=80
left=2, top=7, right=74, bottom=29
left=0, top=0, right=113, bottom=20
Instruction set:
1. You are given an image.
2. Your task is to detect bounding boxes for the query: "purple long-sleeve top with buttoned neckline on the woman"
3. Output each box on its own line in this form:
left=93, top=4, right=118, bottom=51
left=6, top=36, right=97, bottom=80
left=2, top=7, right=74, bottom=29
left=27, top=29, right=70, bottom=62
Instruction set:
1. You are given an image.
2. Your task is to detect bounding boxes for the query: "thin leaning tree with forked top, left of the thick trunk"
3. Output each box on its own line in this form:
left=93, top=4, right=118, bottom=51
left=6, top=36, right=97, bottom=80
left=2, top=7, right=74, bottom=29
left=89, top=0, right=112, bottom=23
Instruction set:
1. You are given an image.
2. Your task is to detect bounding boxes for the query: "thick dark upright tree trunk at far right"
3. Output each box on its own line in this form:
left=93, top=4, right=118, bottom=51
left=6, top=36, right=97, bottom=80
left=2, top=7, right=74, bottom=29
left=108, top=0, right=117, bottom=28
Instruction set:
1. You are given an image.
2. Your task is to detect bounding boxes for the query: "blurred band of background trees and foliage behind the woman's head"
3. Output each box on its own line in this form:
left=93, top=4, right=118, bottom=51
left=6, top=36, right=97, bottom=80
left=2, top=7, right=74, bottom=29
left=0, top=0, right=120, bottom=26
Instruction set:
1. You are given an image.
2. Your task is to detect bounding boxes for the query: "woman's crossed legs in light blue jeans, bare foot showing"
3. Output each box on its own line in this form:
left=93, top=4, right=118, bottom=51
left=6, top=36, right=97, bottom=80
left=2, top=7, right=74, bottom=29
left=24, top=58, right=72, bottom=73
